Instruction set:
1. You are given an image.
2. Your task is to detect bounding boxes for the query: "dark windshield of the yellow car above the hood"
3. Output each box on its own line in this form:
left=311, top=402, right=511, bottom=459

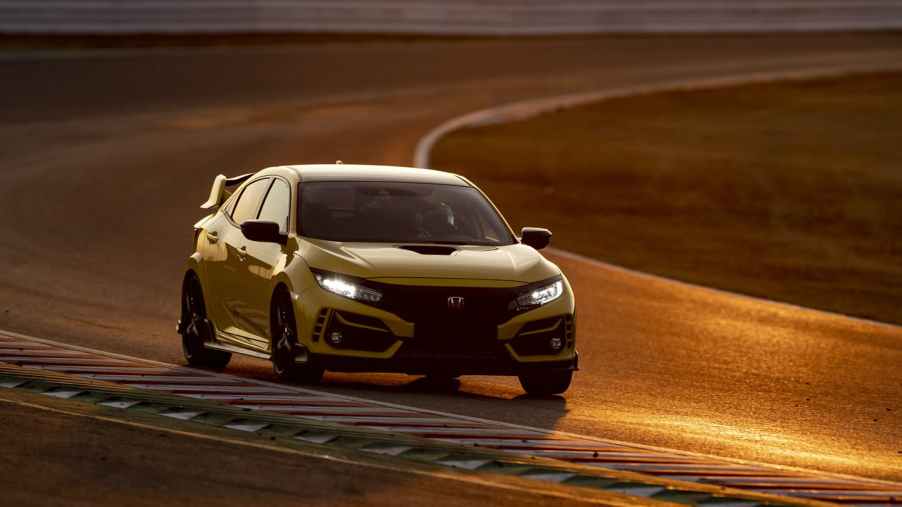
left=299, top=181, right=515, bottom=245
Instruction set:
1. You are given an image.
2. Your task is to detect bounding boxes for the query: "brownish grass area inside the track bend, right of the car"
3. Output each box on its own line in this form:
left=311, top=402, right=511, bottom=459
left=433, top=73, right=902, bottom=323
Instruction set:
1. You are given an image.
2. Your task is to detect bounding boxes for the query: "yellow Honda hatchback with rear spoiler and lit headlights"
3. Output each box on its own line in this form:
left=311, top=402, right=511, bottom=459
left=178, top=164, right=578, bottom=395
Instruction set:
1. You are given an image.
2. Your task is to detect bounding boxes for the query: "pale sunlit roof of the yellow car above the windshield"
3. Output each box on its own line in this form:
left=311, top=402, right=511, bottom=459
left=285, top=164, right=470, bottom=186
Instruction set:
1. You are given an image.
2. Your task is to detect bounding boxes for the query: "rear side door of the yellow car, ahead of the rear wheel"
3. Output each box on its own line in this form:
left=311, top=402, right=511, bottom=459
left=207, top=177, right=272, bottom=348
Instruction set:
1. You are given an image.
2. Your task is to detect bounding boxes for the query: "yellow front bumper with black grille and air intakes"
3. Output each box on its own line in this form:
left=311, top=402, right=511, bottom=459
left=295, top=282, right=578, bottom=375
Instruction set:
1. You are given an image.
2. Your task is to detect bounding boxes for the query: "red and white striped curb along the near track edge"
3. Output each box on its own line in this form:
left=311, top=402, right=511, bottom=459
left=0, top=331, right=902, bottom=505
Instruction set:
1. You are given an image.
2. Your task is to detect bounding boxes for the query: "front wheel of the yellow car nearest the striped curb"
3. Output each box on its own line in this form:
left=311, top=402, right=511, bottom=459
left=270, top=292, right=324, bottom=384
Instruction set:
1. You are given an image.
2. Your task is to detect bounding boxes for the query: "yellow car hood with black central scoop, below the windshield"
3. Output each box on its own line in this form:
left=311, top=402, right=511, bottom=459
left=300, top=239, right=560, bottom=283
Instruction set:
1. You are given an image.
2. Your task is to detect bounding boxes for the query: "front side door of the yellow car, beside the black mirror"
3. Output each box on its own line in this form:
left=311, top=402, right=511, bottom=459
left=245, top=177, right=291, bottom=346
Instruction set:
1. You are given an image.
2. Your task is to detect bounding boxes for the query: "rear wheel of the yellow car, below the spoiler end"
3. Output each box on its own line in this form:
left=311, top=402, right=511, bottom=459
left=182, top=274, right=232, bottom=370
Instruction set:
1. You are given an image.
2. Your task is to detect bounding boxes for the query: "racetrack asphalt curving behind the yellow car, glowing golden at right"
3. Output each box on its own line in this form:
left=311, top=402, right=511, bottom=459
left=0, top=34, right=902, bottom=480
